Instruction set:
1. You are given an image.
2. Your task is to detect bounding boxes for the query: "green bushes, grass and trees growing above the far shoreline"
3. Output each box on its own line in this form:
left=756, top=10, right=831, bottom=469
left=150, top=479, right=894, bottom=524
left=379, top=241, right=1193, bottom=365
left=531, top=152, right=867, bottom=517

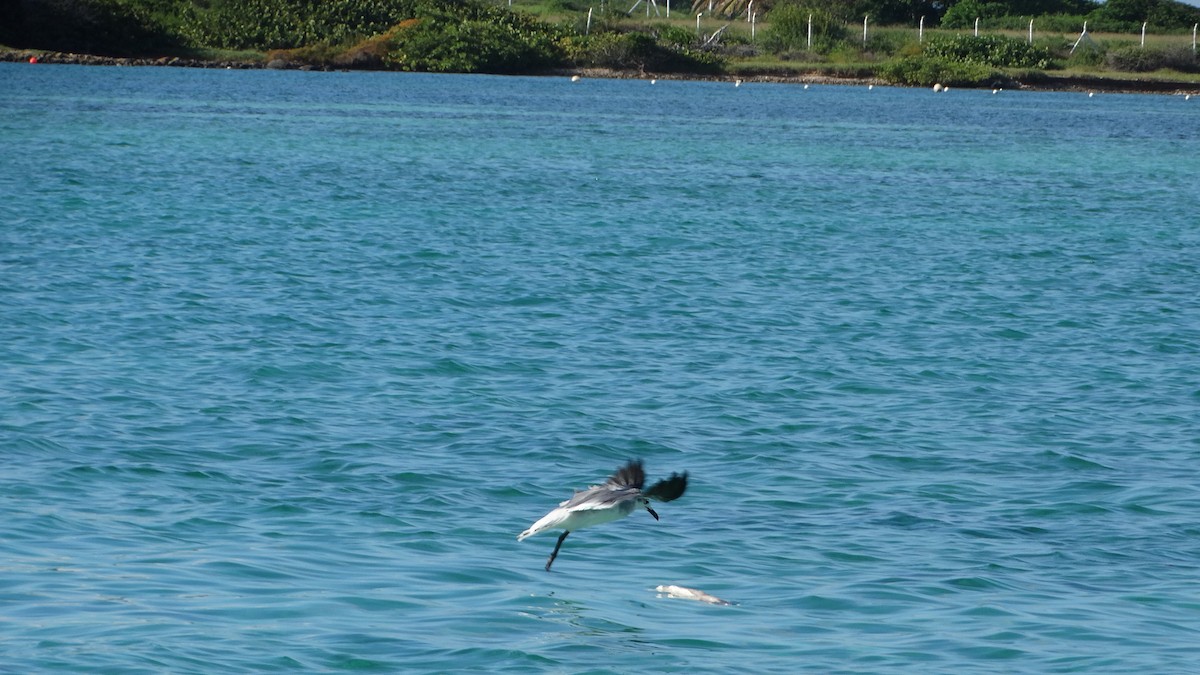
left=0, top=0, right=1200, bottom=86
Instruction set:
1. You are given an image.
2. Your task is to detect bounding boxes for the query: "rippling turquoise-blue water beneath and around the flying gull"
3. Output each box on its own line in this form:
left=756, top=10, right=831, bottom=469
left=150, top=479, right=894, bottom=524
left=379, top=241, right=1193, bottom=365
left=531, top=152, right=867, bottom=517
left=0, top=64, right=1200, bottom=673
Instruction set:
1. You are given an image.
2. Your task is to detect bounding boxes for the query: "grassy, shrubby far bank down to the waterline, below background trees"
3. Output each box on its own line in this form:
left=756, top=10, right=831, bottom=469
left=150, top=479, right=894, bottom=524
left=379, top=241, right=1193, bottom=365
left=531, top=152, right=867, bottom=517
left=7, top=0, right=1200, bottom=90
